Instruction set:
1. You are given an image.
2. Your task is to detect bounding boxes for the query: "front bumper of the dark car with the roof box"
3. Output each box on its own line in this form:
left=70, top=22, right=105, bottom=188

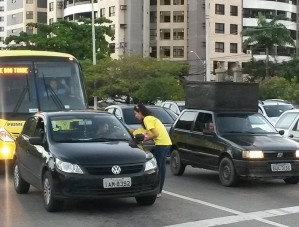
left=233, top=159, right=299, bottom=179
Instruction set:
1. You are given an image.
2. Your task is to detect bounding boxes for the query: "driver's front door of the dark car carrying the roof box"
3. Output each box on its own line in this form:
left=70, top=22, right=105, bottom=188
left=189, top=112, right=220, bottom=167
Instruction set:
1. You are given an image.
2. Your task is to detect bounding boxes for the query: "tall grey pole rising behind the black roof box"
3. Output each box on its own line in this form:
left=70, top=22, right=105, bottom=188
left=205, top=0, right=211, bottom=81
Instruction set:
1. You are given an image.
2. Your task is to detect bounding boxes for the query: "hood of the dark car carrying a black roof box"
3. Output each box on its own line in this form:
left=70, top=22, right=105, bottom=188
left=222, top=135, right=299, bottom=151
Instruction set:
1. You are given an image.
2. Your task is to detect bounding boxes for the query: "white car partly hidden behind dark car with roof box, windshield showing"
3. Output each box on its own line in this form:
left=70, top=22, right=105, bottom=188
left=258, top=99, right=294, bottom=125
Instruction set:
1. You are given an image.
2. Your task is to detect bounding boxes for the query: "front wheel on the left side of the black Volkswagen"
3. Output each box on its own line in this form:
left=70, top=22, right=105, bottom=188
left=43, top=171, right=64, bottom=212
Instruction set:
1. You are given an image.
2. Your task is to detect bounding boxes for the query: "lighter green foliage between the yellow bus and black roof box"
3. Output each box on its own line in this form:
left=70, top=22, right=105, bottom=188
left=82, top=55, right=189, bottom=103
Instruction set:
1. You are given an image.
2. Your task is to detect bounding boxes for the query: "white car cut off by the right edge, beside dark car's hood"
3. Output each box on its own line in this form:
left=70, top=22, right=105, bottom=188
left=274, top=109, right=299, bottom=142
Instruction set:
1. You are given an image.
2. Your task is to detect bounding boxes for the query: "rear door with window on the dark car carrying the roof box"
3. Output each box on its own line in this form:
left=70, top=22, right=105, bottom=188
left=171, top=110, right=197, bottom=163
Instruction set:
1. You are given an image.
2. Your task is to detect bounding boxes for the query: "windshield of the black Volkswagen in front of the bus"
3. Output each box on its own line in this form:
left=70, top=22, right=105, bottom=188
left=49, top=114, right=131, bottom=143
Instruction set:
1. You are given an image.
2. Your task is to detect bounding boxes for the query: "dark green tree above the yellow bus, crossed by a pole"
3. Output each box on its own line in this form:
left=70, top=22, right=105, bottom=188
left=5, top=18, right=114, bottom=59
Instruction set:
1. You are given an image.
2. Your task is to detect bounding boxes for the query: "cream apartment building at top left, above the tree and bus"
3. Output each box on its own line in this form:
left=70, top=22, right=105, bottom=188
left=5, top=0, right=47, bottom=40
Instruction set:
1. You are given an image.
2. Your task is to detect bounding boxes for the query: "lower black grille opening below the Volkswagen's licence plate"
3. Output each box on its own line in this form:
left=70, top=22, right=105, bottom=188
left=66, top=183, right=157, bottom=196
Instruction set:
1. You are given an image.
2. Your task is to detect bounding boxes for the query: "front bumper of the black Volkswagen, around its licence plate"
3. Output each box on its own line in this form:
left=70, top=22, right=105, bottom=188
left=52, top=168, right=160, bottom=199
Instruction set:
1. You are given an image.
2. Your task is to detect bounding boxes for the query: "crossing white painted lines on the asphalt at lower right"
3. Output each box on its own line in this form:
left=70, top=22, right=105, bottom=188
left=163, top=191, right=299, bottom=227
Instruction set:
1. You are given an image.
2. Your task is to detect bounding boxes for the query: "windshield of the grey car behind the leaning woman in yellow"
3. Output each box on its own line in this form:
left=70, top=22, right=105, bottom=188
left=123, top=107, right=177, bottom=125
